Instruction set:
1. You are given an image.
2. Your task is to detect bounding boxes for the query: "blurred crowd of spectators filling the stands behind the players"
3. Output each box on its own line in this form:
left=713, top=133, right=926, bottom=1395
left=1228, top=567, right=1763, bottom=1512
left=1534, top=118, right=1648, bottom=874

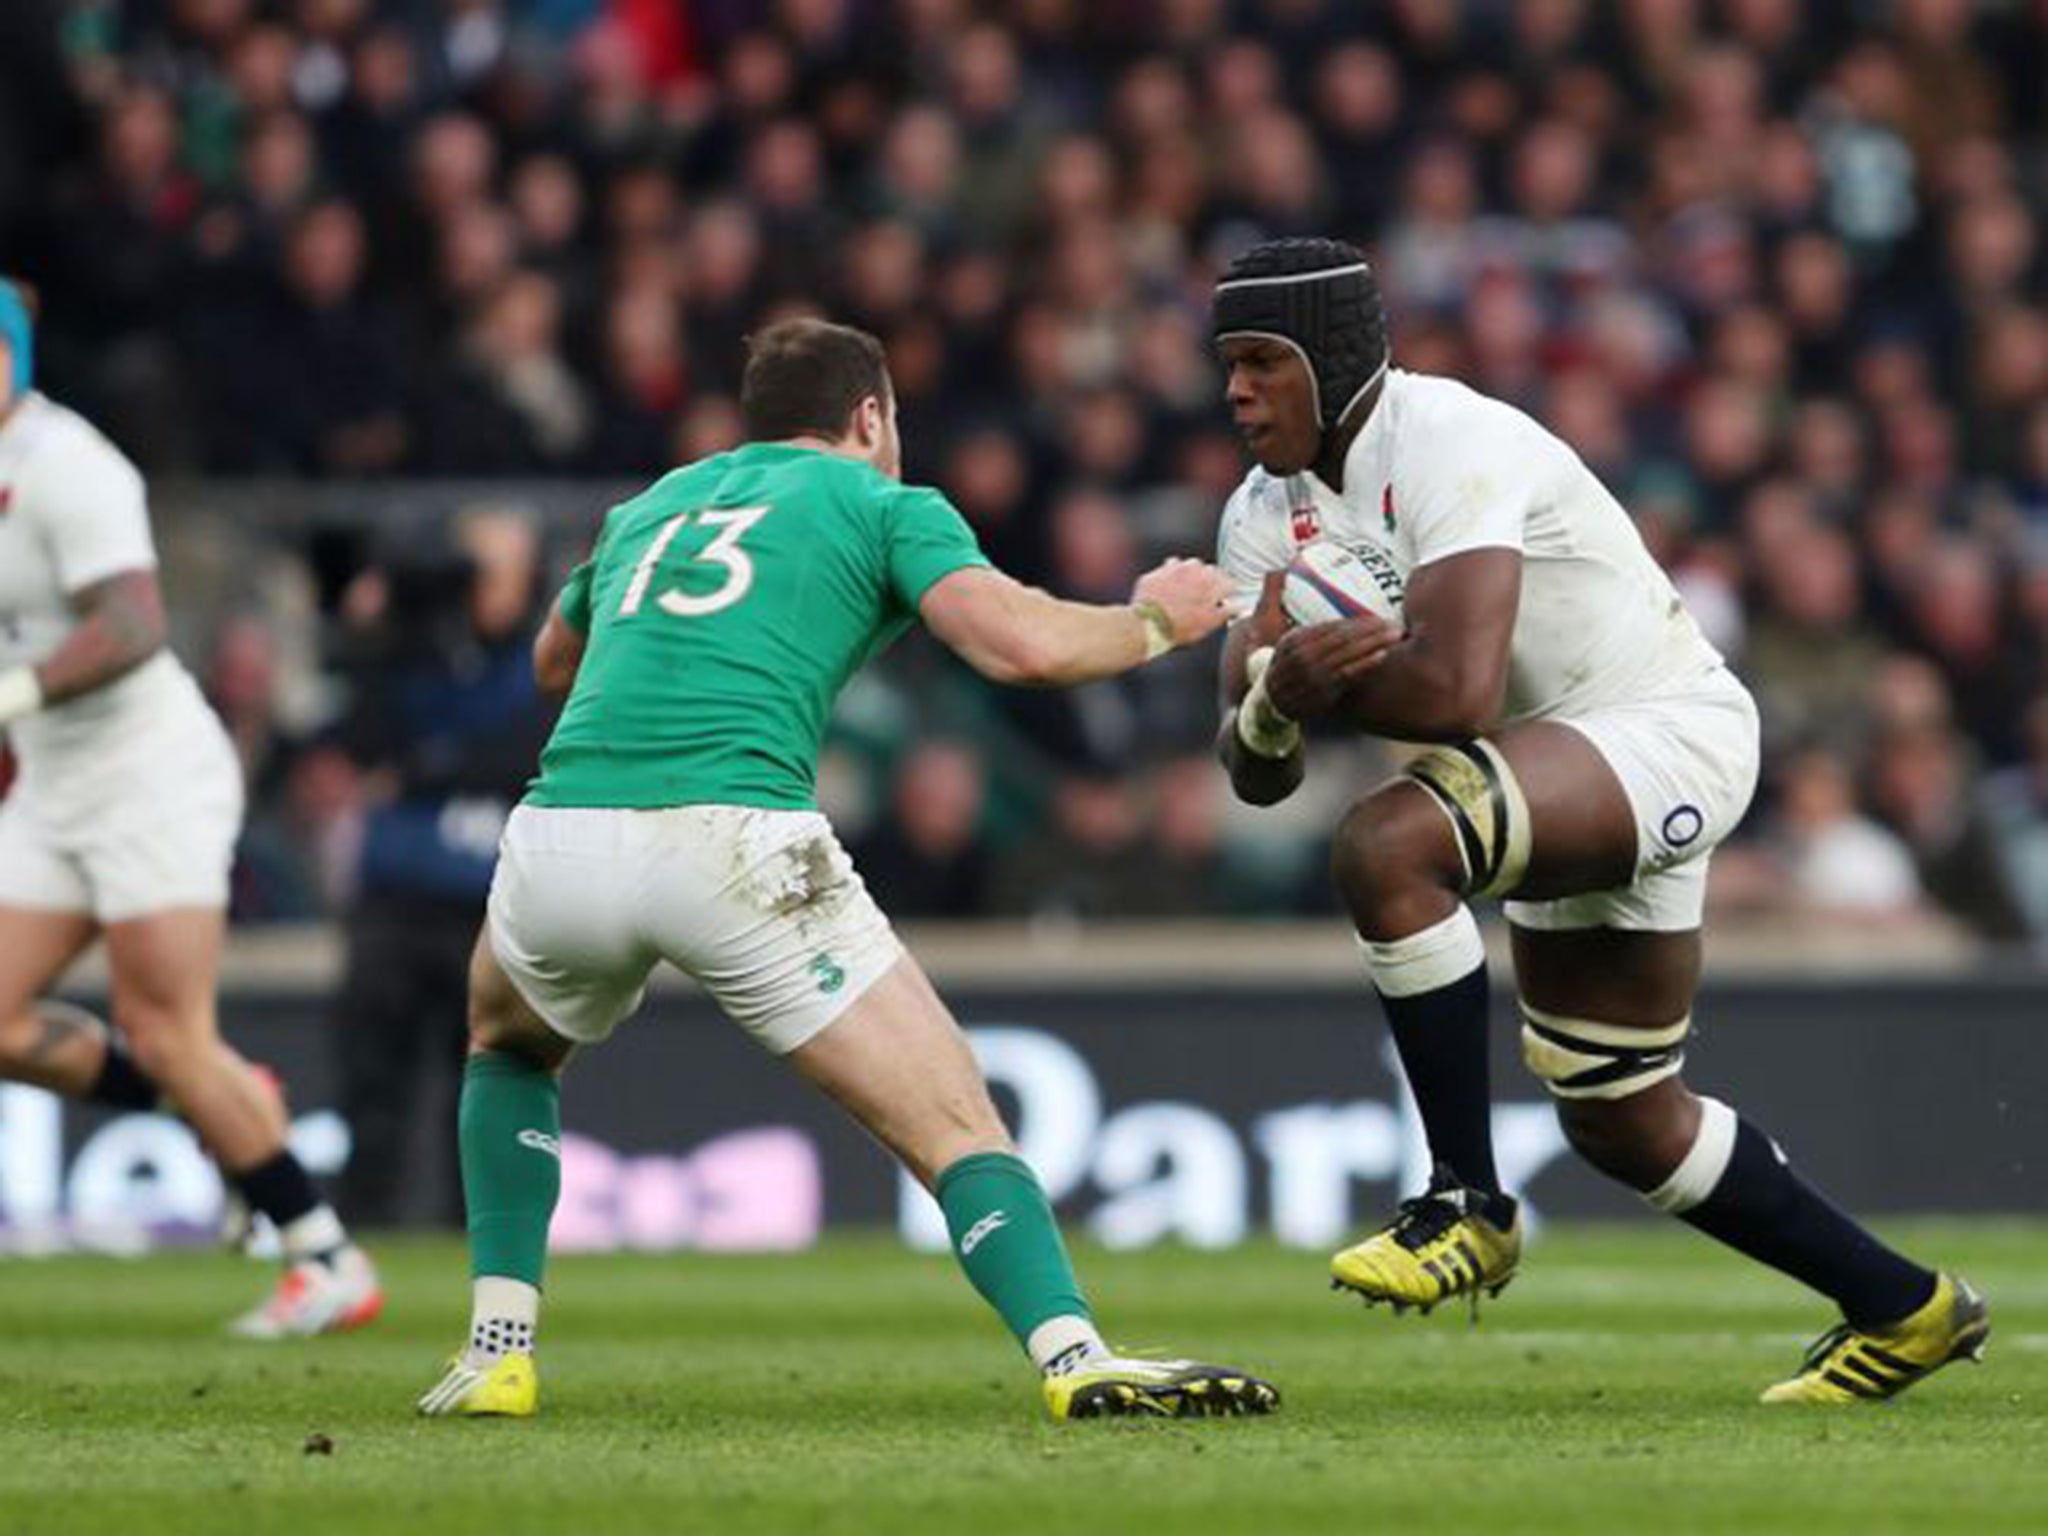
left=0, top=0, right=2048, bottom=946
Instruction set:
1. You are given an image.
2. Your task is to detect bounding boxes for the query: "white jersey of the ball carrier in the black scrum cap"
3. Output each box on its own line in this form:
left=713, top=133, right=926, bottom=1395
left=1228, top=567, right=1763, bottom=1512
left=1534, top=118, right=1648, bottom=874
left=1217, top=369, right=1722, bottom=721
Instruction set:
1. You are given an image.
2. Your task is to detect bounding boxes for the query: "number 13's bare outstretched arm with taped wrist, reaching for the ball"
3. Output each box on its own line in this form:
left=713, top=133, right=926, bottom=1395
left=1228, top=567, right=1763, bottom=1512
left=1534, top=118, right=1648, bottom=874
left=918, top=559, right=1229, bottom=688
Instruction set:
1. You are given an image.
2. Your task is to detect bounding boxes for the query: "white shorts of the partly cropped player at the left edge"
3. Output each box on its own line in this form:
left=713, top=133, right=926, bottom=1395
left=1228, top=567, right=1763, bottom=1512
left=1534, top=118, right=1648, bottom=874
left=0, top=715, right=242, bottom=924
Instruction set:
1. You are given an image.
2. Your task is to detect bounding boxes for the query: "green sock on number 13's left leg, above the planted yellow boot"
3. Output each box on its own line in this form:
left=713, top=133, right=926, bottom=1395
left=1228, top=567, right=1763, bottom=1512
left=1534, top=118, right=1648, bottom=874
left=457, top=1051, right=561, bottom=1290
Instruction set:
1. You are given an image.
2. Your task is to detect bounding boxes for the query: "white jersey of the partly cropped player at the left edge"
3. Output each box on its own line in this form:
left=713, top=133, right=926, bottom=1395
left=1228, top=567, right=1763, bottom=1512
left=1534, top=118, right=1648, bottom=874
left=0, top=393, right=219, bottom=813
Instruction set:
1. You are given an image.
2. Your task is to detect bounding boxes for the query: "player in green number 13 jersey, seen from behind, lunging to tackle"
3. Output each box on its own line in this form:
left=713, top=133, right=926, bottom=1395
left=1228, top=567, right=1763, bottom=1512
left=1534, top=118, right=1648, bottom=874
left=420, top=319, right=1280, bottom=1419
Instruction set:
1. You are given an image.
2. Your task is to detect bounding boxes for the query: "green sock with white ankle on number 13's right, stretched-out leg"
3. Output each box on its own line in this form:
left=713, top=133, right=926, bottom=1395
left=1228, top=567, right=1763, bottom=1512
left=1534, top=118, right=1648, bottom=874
left=934, top=1153, right=1102, bottom=1370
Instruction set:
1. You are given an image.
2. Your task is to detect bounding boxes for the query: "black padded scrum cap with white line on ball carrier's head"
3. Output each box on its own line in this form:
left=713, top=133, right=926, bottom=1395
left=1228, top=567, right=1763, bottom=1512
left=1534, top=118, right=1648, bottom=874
left=1214, top=240, right=1386, bottom=432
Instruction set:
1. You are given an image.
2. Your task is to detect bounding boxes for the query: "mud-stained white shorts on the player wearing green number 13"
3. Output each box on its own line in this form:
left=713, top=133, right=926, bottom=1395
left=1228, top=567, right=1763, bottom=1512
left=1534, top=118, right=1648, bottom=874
left=485, top=805, right=903, bottom=1055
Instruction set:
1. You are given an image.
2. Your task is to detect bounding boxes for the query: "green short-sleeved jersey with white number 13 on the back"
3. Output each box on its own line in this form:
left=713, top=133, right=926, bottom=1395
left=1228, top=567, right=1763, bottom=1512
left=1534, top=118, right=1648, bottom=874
left=526, top=442, right=987, bottom=809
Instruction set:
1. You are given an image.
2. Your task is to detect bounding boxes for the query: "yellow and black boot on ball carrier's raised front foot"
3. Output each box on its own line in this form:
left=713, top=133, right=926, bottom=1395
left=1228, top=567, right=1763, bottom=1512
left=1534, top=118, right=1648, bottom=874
left=1329, top=1165, right=1522, bottom=1313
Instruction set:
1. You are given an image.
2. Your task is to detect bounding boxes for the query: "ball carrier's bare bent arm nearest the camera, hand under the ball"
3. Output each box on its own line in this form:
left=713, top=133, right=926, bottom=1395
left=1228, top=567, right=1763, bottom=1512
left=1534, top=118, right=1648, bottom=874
left=1266, top=549, right=1522, bottom=741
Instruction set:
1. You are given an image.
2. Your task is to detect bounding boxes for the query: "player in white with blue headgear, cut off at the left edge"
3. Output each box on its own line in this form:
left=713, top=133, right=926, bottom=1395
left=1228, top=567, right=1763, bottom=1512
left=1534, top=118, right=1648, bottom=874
left=0, top=281, right=383, bottom=1337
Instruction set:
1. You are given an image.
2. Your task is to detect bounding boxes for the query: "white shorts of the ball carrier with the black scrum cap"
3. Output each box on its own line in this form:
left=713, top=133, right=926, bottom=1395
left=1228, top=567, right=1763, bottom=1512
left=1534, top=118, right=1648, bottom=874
left=1503, top=668, right=1757, bottom=932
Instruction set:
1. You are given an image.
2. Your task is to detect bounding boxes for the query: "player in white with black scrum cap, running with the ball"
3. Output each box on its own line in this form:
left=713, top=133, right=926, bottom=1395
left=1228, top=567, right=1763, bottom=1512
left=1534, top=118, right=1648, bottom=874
left=1214, top=240, right=1989, bottom=1403
